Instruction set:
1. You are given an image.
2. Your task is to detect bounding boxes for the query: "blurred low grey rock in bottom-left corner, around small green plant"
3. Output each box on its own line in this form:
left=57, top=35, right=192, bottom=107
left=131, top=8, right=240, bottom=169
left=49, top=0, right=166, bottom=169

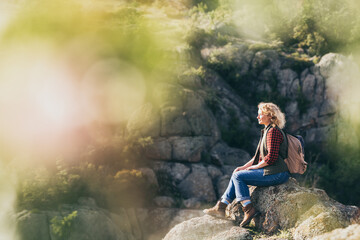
left=17, top=206, right=137, bottom=240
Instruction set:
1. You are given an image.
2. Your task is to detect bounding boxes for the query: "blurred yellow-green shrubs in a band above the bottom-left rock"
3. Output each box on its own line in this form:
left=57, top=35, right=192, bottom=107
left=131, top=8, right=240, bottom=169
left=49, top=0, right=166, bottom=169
left=16, top=158, right=157, bottom=210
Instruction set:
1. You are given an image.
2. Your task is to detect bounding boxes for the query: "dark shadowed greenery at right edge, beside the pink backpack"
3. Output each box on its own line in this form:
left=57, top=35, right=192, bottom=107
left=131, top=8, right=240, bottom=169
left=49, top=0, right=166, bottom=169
left=303, top=122, right=360, bottom=206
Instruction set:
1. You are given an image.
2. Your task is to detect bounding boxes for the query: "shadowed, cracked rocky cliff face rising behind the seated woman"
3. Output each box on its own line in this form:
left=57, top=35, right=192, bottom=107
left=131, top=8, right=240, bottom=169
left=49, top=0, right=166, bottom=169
left=127, top=49, right=343, bottom=210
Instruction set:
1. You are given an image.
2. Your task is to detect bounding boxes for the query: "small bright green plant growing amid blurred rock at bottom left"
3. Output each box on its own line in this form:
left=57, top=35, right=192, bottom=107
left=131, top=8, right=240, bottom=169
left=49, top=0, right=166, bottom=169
left=50, top=211, right=77, bottom=240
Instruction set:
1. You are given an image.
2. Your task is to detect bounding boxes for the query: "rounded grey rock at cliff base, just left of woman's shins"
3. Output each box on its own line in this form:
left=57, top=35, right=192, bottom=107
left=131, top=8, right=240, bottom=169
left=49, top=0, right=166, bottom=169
left=178, top=164, right=216, bottom=202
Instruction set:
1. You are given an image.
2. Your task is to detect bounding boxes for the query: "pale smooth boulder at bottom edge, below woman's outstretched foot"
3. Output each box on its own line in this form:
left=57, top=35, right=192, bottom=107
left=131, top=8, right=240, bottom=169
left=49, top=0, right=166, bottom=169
left=164, top=215, right=252, bottom=240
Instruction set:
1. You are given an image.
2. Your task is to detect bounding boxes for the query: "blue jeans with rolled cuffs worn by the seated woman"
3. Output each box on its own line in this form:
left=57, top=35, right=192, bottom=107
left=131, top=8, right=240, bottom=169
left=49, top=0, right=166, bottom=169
left=221, top=168, right=290, bottom=203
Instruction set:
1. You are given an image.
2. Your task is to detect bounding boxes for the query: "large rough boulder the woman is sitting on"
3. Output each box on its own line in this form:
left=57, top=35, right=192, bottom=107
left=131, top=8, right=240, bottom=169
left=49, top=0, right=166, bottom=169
left=229, top=178, right=359, bottom=240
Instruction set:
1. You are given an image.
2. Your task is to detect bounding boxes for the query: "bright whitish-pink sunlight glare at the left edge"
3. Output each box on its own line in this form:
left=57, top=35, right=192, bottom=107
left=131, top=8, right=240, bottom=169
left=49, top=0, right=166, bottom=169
left=0, top=44, right=82, bottom=152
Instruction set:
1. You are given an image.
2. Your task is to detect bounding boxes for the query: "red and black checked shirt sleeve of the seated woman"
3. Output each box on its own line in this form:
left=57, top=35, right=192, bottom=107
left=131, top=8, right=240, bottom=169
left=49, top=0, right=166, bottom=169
left=264, top=128, right=284, bottom=165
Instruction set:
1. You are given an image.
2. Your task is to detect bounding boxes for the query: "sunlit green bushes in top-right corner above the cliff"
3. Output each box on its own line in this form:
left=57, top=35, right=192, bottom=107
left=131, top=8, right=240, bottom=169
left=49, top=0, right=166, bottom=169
left=283, top=0, right=360, bottom=56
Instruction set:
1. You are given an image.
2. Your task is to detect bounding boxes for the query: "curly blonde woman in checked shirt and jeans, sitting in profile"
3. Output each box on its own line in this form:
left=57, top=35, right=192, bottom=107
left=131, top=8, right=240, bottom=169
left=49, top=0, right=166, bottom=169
left=204, top=102, right=290, bottom=227
